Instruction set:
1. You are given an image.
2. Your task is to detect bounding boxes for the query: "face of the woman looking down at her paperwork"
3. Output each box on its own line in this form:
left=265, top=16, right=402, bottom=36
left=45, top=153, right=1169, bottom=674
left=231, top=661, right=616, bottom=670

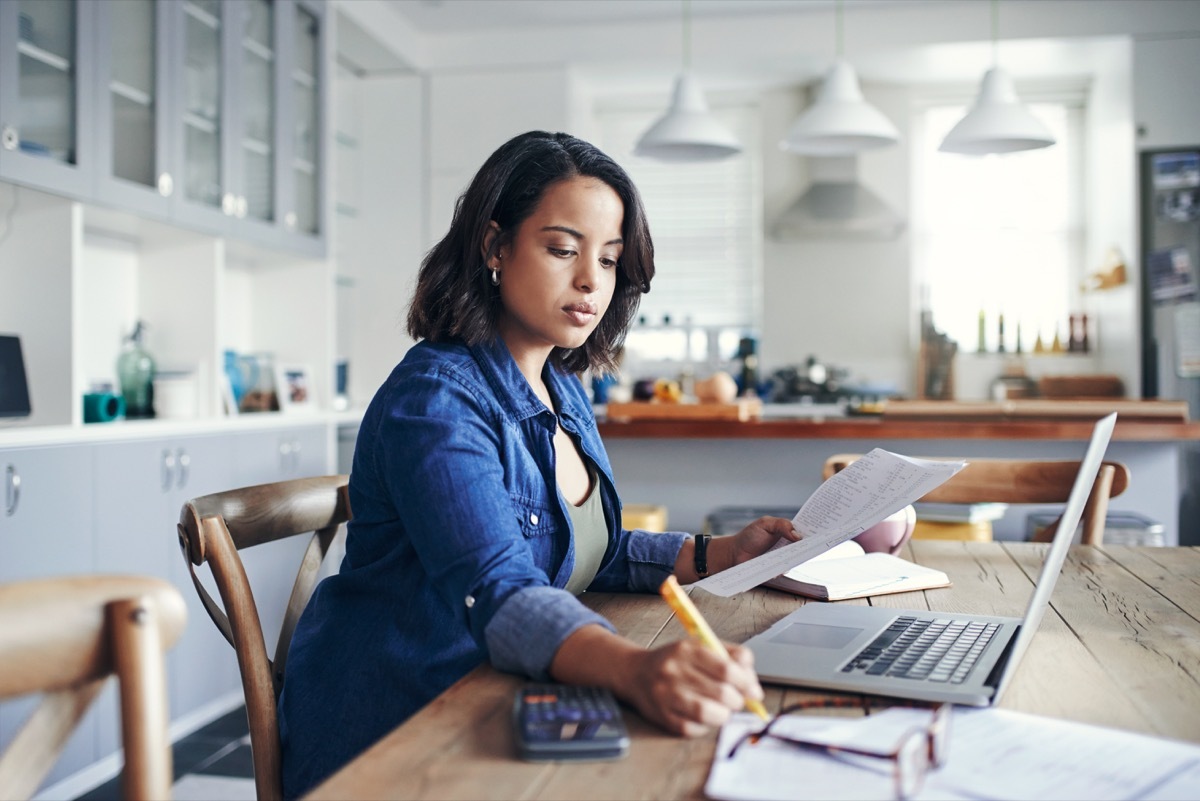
left=488, top=176, right=625, bottom=369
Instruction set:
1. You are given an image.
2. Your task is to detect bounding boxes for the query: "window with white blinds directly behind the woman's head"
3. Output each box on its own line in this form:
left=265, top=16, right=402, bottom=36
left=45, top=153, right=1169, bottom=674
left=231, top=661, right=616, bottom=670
left=596, top=100, right=762, bottom=367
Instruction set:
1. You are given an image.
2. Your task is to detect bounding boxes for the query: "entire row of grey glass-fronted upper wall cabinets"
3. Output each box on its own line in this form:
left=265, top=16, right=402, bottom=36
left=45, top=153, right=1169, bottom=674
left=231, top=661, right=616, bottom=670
left=0, top=0, right=331, bottom=258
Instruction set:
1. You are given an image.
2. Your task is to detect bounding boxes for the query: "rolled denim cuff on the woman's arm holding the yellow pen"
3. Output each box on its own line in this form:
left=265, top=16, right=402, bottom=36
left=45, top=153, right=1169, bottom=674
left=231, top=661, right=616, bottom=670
left=484, top=586, right=616, bottom=681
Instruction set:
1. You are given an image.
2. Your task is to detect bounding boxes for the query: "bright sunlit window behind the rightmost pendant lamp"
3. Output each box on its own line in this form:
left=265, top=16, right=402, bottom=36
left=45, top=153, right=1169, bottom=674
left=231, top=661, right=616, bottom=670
left=912, top=96, right=1085, bottom=353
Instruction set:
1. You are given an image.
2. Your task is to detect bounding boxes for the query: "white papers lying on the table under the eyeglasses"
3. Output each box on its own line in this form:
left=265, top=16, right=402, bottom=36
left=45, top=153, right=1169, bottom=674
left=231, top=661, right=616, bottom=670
left=704, top=707, right=1200, bottom=801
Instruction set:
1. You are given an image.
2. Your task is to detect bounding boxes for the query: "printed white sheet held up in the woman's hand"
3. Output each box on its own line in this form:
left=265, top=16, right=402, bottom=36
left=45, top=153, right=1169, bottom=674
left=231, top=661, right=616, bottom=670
left=696, top=447, right=966, bottom=597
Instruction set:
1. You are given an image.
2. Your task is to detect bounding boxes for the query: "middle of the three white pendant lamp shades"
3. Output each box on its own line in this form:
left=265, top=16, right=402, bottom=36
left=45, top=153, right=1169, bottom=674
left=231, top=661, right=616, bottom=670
left=779, top=59, right=900, bottom=156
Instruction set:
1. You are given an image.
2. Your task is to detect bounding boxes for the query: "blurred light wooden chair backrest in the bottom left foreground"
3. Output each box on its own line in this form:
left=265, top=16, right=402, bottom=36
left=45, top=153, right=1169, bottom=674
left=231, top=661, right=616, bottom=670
left=0, top=576, right=187, bottom=799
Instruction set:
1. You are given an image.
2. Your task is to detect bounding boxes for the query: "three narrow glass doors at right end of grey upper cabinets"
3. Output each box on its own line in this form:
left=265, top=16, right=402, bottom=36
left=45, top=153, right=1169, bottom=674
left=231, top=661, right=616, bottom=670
left=172, top=0, right=329, bottom=255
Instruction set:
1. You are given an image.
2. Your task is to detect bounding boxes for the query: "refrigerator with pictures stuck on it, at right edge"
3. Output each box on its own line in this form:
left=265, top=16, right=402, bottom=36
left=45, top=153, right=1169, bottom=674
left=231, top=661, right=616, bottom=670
left=1140, top=145, right=1200, bottom=546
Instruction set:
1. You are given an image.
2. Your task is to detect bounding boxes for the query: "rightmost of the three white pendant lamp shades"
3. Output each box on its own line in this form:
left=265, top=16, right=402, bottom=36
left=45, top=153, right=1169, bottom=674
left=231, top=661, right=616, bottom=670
left=938, top=67, right=1055, bottom=156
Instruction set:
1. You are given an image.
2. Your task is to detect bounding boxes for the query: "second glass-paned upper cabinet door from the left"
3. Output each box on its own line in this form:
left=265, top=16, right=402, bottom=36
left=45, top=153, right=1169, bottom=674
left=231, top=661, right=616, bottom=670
left=96, top=0, right=174, bottom=216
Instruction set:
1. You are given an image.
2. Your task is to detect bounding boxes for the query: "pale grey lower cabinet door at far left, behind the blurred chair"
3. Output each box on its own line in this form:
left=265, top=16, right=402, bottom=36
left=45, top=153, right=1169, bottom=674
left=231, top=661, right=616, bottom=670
left=0, top=443, right=97, bottom=782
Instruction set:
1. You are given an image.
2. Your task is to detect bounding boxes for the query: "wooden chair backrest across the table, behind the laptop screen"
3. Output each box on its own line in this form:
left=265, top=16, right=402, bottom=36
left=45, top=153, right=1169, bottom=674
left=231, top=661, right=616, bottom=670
left=823, top=453, right=1129, bottom=546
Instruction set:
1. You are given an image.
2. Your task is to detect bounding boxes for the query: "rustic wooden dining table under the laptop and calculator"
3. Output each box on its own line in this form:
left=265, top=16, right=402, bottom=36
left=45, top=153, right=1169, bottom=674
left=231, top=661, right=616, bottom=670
left=307, top=541, right=1200, bottom=801
